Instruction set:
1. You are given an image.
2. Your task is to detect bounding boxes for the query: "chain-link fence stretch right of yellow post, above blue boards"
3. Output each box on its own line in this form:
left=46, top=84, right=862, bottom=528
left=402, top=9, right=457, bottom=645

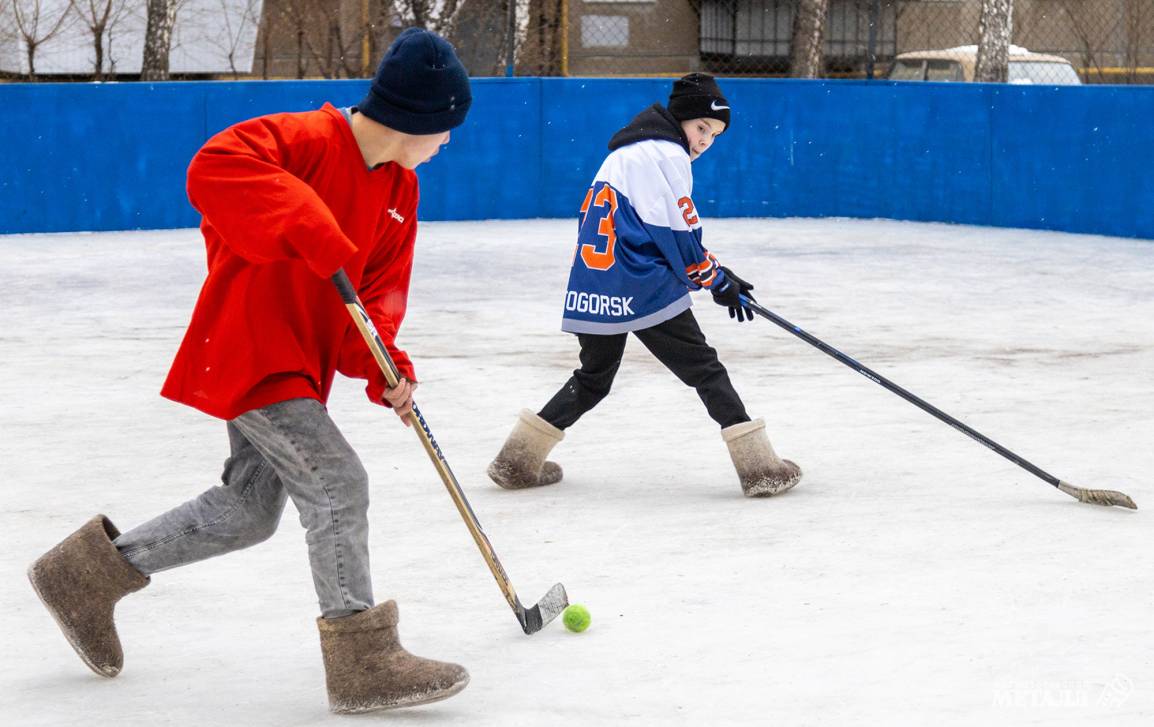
left=564, top=0, right=1154, bottom=83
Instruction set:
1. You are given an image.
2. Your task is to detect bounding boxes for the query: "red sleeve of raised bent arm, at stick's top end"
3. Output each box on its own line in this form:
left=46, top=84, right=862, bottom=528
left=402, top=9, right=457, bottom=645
left=188, top=114, right=357, bottom=278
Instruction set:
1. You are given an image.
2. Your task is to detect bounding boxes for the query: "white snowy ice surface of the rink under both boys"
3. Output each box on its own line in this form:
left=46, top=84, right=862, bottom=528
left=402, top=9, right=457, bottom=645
left=0, top=219, right=1154, bottom=727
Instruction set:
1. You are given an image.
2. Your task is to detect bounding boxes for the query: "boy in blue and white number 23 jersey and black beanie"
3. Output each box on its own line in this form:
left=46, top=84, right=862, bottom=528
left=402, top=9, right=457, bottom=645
left=488, top=73, right=801, bottom=497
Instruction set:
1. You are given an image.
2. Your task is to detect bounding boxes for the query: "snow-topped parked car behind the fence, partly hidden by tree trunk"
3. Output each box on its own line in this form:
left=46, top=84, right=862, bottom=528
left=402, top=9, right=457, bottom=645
left=886, top=45, right=1081, bottom=85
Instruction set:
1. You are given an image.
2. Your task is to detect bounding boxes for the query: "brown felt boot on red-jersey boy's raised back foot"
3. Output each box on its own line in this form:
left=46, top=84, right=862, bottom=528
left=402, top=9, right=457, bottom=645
left=28, top=515, right=149, bottom=677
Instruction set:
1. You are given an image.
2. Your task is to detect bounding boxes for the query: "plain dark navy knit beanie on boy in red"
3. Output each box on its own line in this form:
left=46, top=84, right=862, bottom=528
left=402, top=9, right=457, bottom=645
left=357, top=28, right=473, bottom=134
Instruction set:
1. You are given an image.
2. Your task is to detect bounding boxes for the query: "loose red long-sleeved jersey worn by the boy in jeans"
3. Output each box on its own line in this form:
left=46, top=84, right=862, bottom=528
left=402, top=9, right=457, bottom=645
left=160, top=104, right=418, bottom=419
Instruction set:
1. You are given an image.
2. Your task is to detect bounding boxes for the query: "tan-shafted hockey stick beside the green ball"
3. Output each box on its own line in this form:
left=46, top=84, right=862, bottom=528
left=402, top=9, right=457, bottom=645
left=332, top=270, right=569, bottom=634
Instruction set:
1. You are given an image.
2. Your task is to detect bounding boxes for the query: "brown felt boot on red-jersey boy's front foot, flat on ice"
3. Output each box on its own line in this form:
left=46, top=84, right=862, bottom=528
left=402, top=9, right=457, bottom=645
left=316, top=601, right=469, bottom=714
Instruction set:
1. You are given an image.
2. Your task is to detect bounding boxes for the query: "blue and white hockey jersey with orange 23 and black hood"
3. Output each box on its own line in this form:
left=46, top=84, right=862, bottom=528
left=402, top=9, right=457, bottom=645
left=561, top=105, right=721, bottom=335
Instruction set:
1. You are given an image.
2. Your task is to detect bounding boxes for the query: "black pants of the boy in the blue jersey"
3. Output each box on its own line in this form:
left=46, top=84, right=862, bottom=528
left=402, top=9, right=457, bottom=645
left=538, top=310, right=749, bottom=429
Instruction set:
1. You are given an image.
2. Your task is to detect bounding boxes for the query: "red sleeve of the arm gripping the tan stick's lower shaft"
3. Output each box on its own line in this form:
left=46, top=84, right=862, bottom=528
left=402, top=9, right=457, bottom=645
left=337, top=208, right=417, bottom=406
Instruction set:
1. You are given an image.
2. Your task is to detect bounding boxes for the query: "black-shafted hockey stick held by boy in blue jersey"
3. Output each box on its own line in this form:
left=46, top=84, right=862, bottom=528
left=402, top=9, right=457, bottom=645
left=741, top=295, right=1138, bottom=510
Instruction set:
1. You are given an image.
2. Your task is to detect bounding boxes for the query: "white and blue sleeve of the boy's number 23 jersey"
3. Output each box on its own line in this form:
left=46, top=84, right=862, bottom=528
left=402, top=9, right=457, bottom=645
left=635, top=157, right=724, bottom=290
